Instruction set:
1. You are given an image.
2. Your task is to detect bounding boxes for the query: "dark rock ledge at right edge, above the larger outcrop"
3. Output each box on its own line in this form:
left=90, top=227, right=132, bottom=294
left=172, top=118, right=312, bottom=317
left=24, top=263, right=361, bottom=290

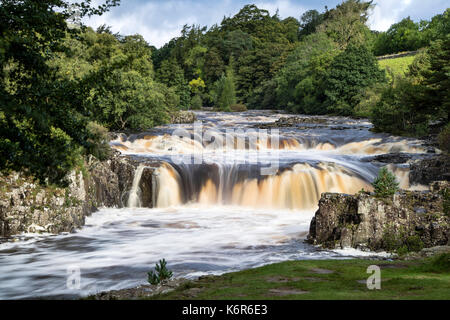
left=409, top=155, right=450, bottom=184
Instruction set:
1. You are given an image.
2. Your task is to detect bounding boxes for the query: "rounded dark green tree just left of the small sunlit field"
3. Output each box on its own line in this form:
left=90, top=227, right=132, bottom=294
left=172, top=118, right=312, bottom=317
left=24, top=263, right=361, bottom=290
left=324, top=46, right=385, bottom=115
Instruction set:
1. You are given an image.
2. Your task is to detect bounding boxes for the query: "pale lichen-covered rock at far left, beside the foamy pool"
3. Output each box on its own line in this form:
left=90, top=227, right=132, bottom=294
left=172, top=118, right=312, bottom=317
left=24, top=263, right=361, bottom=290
left=0, top=172, right=92, bottom=237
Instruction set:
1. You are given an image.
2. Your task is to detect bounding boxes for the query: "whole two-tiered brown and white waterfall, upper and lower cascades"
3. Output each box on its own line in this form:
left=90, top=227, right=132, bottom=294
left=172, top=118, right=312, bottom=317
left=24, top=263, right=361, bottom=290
left=111, top=116, right=424, bottom=210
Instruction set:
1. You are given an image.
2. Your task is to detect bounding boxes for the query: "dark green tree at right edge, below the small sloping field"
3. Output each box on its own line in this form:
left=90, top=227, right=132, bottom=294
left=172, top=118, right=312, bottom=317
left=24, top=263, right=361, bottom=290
left=371, top=34, right=450, bottom=136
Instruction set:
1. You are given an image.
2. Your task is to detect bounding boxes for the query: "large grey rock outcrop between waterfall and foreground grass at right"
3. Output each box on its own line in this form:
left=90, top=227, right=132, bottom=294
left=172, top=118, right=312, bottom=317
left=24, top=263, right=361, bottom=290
left=307, top=182, right=450, bottom=250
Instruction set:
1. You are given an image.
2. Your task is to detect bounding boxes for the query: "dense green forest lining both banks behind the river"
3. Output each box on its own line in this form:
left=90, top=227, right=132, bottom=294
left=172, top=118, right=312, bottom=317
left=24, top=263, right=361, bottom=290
left=0, top=0, right=450, bottom=184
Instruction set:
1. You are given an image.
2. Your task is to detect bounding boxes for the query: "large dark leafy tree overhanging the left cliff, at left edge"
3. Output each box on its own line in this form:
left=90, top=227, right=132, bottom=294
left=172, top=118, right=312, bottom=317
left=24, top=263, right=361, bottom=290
left=0, top=0, right=119, bottom=185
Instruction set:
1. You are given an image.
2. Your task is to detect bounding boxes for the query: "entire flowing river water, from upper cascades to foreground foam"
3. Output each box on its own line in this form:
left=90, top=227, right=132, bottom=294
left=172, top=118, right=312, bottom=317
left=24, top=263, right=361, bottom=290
left=0, top=111, right=426, bottom=299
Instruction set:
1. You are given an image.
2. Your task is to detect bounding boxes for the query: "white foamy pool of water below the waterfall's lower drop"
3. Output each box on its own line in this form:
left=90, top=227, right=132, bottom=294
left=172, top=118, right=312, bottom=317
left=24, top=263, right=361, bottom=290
left=0, top=206, right=324, bottom=299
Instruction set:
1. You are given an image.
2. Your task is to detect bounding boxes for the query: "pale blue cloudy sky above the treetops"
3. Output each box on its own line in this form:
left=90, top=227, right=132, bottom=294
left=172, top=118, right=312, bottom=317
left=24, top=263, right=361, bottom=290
left=85, top=0, right=449, bottom=48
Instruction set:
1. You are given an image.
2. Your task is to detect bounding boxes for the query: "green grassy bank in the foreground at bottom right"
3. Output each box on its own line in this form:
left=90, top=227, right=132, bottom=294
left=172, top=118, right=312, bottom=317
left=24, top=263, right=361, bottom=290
left=151, top=254, right=450, bottom=300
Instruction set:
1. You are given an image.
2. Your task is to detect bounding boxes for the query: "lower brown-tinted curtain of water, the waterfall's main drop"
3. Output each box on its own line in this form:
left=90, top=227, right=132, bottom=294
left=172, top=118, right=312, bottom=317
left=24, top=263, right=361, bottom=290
left=156, top=163, right=372, bottom=210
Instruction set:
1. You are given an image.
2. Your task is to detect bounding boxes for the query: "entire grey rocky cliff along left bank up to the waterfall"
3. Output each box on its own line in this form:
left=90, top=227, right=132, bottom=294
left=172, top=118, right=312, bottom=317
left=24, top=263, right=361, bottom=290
left=0, top=153, right=157, bottom=237
